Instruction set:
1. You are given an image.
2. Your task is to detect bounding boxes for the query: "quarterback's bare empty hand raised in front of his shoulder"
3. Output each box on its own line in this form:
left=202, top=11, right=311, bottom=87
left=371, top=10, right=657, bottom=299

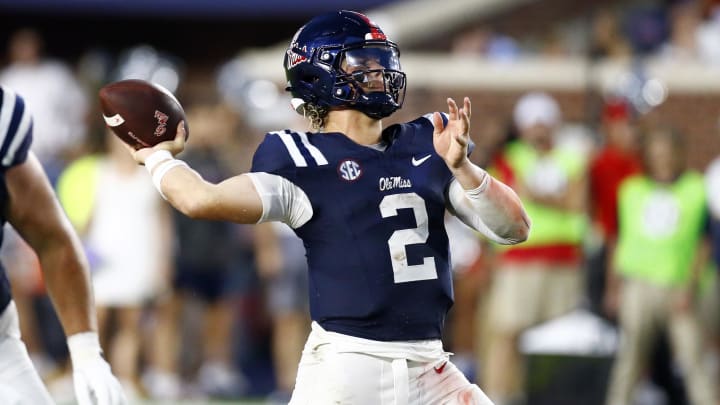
left=433, top=97, right=470, bottom=170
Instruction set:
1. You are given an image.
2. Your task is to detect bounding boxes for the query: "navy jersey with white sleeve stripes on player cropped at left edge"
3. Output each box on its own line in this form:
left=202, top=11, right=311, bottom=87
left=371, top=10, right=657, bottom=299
left=0, top=86, right=32, bottom=311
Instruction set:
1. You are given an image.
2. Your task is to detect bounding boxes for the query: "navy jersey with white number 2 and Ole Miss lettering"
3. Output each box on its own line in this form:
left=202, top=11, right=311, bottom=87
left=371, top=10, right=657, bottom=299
left=252, top=116, right=462, bottom=341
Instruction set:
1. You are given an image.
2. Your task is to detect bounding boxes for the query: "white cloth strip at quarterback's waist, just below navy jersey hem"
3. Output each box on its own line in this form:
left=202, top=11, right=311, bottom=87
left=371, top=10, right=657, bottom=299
left=308, top=321, right=450, bottom=363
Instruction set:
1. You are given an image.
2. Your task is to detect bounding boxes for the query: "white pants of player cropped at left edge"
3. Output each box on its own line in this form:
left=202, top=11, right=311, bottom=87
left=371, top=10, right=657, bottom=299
left=0, top=301, right=54, bottom=405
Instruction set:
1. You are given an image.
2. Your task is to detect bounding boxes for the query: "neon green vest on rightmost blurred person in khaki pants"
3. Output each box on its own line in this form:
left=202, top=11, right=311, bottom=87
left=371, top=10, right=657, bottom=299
left=613, top=171, right=707, bottom=287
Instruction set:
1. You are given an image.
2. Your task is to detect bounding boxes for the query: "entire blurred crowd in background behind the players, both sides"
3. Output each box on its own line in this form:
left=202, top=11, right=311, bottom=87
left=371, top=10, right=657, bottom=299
left=0, top=0, right=720, bottom=405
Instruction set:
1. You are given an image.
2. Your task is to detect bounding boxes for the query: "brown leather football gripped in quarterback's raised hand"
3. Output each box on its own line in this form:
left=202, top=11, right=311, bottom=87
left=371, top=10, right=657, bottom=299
left=99, top=79, right=190, bottom=149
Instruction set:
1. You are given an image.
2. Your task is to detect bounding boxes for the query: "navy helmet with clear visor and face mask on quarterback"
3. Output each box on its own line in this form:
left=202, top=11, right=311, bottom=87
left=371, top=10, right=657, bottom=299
left=283, top=10, right=406, bottom=119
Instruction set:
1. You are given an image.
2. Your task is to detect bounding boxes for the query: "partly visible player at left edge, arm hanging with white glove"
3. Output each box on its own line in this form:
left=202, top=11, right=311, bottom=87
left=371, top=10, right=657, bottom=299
left=0, top=86, right=127, bottom=405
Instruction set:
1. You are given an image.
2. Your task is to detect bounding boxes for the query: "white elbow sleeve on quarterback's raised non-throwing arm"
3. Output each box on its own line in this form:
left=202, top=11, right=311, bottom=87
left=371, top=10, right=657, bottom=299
left=447, top=175, right=520, bottom=245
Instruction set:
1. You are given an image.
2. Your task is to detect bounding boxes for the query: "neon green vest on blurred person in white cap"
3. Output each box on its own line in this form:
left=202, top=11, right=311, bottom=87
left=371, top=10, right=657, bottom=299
left=506, top=141, right=588, bottom=248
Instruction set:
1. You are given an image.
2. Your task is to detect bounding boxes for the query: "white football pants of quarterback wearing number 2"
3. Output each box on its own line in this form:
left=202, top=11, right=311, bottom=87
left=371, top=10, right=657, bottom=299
left=290, top=322, right=493, bottom=405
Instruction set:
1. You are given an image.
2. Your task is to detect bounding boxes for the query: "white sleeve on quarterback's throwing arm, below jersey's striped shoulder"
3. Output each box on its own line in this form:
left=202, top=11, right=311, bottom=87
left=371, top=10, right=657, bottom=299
left=245, top=172, right=313, bottom=229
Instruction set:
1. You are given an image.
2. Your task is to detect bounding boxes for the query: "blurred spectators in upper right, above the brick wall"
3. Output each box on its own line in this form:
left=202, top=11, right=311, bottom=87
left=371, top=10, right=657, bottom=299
left=452, top=0, right=720, bottom=65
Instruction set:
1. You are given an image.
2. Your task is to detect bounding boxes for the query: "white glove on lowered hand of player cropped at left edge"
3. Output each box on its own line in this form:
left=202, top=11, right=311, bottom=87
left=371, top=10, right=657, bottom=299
left=67, top=332, right=128, bottom=405
